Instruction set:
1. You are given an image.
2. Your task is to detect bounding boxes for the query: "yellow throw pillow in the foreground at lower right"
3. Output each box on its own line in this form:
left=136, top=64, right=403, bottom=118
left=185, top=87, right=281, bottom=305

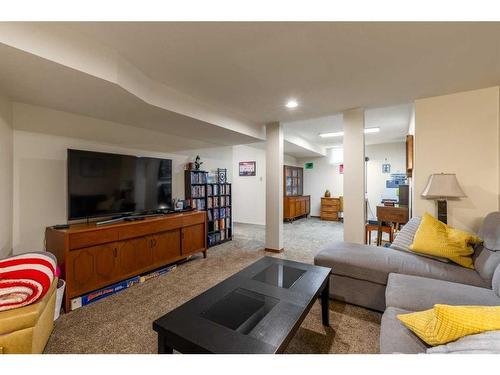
left=398, top=305, right=500, bottom=346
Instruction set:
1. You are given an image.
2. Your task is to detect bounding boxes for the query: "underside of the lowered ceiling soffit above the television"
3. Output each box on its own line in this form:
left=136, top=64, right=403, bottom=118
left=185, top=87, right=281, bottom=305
left=0, top=43, right=257, bottom=151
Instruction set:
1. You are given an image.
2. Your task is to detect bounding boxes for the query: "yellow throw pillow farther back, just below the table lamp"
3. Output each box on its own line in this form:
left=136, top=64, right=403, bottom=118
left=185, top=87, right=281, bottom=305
left=410, top=212, right=481, bottom=269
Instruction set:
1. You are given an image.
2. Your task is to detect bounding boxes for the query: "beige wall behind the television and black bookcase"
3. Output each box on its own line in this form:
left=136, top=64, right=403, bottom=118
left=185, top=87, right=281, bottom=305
left=11, top=105, right=232, bottom=253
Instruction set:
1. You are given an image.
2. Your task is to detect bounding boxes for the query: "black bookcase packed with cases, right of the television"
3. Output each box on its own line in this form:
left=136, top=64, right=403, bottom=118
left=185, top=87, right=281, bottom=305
left=184, top=171, right=233, bottom=247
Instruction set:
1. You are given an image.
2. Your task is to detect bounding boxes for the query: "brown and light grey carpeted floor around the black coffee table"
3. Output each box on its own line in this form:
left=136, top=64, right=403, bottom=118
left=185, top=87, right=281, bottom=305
left=45, top=218, right=381, bottom=353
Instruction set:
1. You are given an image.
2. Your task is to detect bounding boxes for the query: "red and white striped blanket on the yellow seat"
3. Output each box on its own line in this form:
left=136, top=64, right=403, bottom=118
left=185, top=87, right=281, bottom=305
left=0, top=252, right=57, bottom=311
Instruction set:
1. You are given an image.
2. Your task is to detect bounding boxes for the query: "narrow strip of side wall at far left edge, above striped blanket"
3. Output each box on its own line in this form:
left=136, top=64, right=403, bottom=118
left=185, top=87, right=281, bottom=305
left=0, top=95, right=13, bottom=259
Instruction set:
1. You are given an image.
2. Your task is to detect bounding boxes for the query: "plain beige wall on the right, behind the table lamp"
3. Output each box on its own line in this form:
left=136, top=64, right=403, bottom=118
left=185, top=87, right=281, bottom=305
left=414, top=87, right=500, bottom=231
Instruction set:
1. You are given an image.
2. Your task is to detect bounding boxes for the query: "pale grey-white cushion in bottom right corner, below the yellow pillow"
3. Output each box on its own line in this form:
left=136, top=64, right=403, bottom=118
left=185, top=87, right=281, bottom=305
left=427, top=331, right=500, bottom=354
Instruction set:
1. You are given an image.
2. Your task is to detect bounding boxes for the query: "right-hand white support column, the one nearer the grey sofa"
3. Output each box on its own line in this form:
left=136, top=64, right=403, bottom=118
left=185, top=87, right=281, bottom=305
left=343, top=108, right=366, bottom=244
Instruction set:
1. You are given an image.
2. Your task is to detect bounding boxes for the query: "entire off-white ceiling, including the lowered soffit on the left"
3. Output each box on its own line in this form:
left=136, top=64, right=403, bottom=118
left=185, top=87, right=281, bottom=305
left=0, top=22, right=500, bottom=153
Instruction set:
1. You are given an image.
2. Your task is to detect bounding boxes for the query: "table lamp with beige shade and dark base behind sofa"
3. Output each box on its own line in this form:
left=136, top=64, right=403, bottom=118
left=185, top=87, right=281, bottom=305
left=422, top=173, right=466, bottom=224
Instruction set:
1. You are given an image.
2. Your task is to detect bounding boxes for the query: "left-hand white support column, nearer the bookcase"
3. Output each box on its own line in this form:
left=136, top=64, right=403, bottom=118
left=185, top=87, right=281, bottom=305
left=266, top=122, right=284, bottom=252
